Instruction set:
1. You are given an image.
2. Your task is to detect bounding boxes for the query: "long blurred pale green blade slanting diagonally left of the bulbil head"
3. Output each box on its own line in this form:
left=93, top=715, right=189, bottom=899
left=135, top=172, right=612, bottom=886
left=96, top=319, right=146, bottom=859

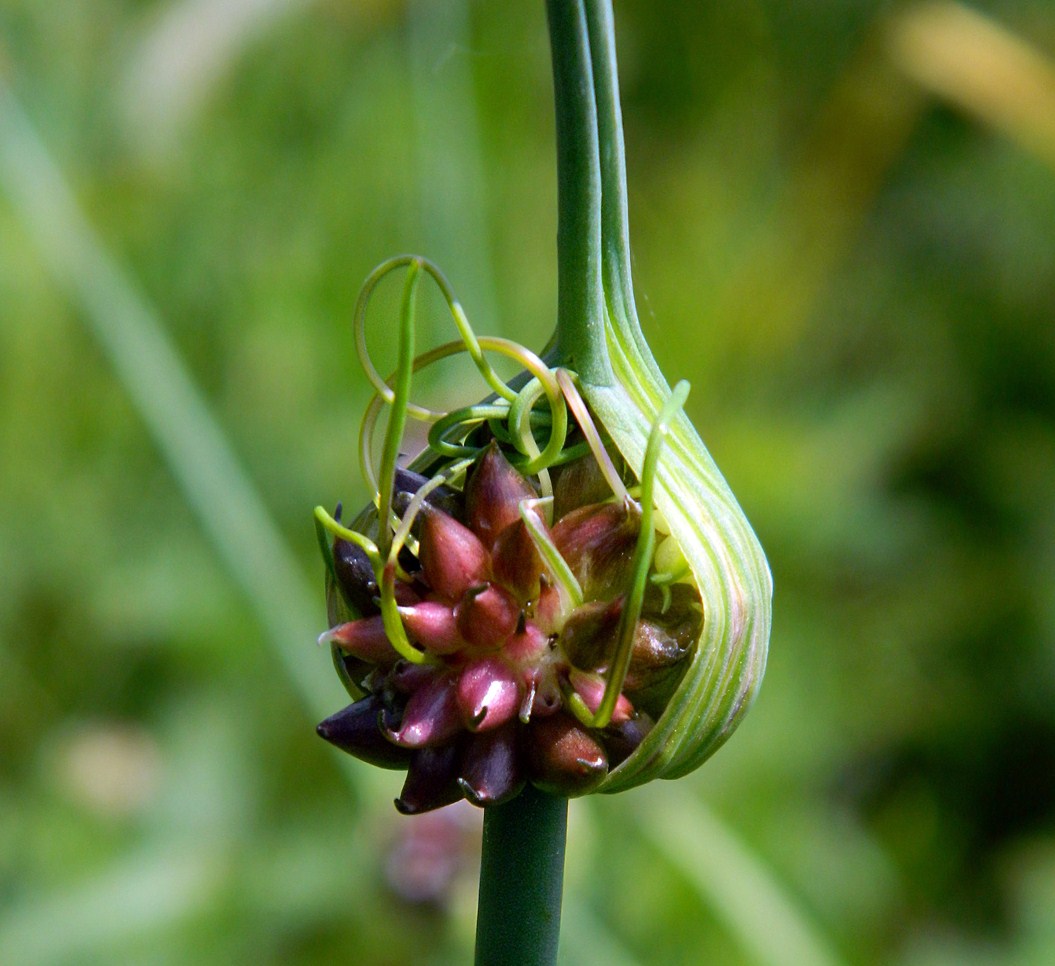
left=0, top=79, right=335, bottom=718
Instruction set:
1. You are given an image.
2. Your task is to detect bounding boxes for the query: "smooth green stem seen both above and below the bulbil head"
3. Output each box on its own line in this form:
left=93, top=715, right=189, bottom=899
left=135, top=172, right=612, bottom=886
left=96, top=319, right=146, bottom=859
left=476, top=0, right=620, bottom=966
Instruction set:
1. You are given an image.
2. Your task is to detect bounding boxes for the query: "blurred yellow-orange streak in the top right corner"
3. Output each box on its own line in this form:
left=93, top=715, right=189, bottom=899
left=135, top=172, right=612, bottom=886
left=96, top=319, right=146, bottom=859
left=888, top=2, right=1055, bottom=174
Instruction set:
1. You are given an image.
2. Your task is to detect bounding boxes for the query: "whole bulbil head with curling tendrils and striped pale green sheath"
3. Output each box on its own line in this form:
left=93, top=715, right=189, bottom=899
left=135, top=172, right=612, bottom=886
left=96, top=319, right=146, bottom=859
left=315, top=245, right=769, bottom=814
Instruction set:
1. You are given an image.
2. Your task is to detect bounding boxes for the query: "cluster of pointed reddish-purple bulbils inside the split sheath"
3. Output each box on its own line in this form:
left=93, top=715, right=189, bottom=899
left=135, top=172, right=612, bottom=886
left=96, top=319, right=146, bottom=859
left=319, top=442, right=703, bottom=814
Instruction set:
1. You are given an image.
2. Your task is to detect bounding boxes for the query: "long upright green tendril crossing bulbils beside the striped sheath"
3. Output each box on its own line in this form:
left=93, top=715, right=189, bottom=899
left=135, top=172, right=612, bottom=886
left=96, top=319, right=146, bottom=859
left=590, top=380, right=689, bottom=728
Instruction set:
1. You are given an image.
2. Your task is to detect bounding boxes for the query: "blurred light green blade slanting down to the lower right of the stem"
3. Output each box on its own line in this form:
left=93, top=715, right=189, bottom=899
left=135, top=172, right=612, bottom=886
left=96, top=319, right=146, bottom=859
left=635, top=783, right=842, bottom=966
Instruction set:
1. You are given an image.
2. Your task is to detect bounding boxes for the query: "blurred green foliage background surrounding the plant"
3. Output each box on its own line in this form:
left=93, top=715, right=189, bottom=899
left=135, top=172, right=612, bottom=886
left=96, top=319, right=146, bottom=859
left=0, top=0, right=1055, bottom=966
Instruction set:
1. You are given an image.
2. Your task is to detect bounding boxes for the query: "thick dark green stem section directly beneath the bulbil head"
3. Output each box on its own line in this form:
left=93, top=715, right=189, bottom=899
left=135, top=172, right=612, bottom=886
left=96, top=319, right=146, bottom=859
left=476, top=785, right=568, bottom=966
